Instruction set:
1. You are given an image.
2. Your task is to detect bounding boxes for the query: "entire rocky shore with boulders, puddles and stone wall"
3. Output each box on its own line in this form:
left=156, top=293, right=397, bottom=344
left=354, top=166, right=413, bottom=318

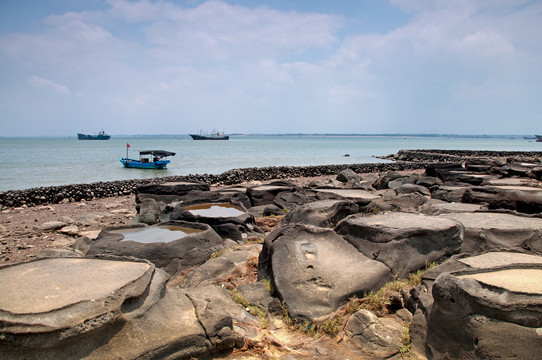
left=0, top=150, right=542, bottom=360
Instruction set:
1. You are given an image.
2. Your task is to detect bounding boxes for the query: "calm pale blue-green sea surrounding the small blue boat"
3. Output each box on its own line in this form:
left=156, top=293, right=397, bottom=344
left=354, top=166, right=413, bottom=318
left=0, top=134, right=542, bottom=191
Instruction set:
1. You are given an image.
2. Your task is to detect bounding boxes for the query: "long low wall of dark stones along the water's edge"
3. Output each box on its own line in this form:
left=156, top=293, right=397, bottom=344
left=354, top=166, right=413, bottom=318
left=4, top=150, right=542, bottom=208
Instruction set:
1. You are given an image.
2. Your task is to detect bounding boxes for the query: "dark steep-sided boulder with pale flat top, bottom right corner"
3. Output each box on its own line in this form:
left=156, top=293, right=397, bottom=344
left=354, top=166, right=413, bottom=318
left=426, top=266, right=542, bottom=359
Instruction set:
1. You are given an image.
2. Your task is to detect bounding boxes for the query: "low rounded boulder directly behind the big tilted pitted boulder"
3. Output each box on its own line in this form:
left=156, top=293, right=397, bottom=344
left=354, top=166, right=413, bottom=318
left=284, top=200, right=359, bottom=227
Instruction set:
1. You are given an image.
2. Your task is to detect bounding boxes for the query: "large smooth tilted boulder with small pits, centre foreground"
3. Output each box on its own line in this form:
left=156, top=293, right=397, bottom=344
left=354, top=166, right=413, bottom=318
left=258, top=224, right=392, bottom=320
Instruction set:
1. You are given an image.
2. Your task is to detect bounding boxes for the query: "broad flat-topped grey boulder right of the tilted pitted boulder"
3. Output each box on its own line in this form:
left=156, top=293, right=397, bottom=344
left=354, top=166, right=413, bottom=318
left=335, top=212, right=463, bottom=277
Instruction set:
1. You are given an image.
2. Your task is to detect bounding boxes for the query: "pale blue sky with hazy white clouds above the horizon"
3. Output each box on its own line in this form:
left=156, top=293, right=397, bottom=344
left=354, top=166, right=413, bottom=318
left=0, top=0, right=542, bottom=136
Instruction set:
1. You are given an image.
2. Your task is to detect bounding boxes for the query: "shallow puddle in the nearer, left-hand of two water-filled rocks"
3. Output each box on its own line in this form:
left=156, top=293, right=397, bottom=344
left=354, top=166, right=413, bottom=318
left=115, top=226, right=202, bottom=244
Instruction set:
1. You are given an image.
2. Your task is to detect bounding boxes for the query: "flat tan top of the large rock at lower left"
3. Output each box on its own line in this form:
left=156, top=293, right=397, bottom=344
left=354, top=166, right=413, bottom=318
left=0, top=258, right=154, bottom=316
